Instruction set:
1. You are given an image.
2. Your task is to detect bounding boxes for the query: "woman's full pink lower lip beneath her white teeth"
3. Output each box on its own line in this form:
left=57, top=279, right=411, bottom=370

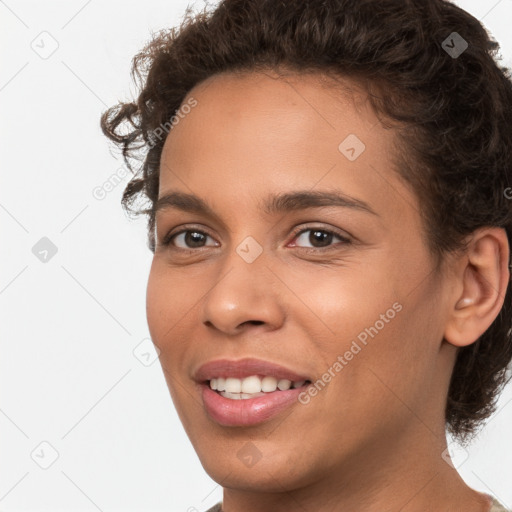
left=201, top=384, right=306, bottom=427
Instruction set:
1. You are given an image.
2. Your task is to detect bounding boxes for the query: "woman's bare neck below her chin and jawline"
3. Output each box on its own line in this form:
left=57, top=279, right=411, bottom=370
left=222, top=421, right=491, bottom=512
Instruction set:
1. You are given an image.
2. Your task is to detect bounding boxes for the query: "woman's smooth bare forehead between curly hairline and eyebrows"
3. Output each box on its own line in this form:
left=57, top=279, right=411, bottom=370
left=160, top=72, right=414, bottom=226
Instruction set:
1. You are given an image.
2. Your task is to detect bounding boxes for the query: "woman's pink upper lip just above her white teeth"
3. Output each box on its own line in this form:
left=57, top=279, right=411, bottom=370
left=194, top=358, right=312, bottom=384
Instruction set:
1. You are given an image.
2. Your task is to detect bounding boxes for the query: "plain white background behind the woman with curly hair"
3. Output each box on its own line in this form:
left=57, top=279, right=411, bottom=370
left=0, top=0, right=512, bottom=512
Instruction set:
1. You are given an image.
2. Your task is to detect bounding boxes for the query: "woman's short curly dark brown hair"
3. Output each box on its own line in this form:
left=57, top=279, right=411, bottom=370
left=101, top=0, right=512, bottom=443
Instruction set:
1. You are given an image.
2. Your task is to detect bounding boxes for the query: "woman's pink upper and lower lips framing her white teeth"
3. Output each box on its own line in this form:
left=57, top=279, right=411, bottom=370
left=194, top=358, right=312, bottom=427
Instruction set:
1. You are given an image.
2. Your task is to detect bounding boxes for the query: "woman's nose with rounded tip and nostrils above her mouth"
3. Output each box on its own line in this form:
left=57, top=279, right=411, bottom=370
left=203, top=253, right=285, bottom=336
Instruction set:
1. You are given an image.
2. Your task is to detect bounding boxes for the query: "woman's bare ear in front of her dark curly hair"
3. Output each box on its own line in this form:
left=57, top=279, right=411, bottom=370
left=444, top=227, right=510, bottom=347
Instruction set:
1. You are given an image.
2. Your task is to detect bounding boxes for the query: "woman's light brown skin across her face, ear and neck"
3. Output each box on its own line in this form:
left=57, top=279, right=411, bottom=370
left=147, top=72, right=509, bottom=512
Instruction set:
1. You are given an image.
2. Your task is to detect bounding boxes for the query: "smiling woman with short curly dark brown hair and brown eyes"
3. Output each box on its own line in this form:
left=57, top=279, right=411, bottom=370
left=102, top=0, right=512, bottom=512
